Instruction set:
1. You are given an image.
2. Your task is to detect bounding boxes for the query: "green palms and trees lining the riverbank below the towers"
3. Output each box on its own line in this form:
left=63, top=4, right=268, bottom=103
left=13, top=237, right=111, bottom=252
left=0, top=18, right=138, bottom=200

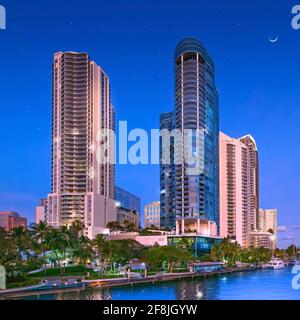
left=0, top=221, right=297, bottom=286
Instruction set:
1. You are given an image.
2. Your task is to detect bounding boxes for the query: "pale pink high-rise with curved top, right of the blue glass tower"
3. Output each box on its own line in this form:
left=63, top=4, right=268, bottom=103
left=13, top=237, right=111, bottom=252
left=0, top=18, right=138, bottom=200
left=220, top=133, right=259, bottom=247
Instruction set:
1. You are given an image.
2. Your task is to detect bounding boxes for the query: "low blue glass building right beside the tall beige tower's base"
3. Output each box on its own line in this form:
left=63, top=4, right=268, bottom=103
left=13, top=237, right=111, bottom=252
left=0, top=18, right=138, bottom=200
left=115, top=186, right=141, bottom=228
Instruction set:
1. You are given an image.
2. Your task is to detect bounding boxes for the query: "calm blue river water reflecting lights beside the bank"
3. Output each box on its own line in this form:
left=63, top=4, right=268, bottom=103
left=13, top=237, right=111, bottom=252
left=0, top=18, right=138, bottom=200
left=22, top=268, right=300, bottom=300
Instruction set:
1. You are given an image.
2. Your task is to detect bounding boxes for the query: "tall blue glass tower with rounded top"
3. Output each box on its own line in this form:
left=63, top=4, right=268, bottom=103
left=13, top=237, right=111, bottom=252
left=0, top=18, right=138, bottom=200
left=160, top=38, right=219, bottom=233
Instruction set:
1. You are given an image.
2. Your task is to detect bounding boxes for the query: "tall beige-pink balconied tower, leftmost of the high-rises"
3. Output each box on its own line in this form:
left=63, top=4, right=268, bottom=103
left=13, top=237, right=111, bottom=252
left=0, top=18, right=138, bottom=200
left=47, top=52, right=116, bottom=237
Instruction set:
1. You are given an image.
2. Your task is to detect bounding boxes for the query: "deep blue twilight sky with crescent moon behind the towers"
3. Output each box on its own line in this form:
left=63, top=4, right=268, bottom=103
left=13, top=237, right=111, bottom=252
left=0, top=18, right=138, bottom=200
left=0, top=0, right=300, bottom=245
